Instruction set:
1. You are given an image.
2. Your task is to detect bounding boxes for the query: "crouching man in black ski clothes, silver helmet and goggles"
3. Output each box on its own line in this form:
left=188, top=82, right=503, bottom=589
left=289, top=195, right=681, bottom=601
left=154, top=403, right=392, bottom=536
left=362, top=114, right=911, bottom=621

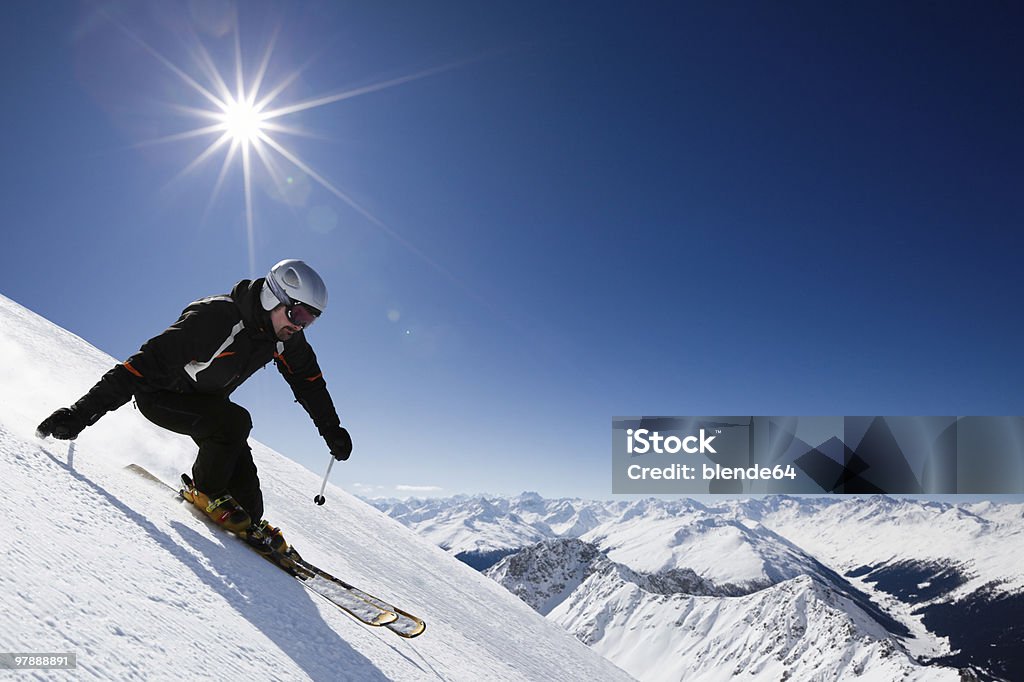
left=36, top=259, right=352, bottom=552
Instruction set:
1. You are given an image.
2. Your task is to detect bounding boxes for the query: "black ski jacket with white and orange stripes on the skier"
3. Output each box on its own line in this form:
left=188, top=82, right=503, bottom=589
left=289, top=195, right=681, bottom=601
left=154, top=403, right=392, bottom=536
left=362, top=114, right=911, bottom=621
left=74, top=278, right=340, bottom=434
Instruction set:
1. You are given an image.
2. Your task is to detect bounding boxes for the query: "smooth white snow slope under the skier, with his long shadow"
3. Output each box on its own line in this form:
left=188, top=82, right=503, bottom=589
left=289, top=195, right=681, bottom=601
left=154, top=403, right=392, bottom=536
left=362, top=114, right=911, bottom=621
left=0, top=296, right=630, bottom=680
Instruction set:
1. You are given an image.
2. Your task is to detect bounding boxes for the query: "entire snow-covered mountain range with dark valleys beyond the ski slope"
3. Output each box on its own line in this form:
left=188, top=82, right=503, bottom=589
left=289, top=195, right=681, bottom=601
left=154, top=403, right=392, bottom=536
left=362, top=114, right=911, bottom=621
left=374, top=494, right=1024, bottom=680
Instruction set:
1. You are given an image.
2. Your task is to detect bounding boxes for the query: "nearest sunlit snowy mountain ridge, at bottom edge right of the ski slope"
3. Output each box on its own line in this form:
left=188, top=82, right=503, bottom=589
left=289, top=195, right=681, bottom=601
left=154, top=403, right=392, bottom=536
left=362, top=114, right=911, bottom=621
left=549, top=571, right=961, bottom=682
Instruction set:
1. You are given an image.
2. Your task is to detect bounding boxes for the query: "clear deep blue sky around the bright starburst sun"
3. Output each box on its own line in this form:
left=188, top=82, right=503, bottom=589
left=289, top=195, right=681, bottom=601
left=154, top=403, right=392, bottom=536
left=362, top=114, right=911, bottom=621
left=0, top=1, right=1024, bottom=497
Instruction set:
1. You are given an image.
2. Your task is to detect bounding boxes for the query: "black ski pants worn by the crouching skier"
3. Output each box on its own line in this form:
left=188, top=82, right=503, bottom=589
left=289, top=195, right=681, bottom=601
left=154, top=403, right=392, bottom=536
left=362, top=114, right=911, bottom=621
left=135, top=391, right=263, bottom=522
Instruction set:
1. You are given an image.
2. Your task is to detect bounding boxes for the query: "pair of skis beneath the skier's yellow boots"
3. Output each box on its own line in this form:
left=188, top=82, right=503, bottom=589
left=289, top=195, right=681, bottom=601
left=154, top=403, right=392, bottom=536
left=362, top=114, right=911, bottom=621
left=125, top=464, right=426, bottom=638
